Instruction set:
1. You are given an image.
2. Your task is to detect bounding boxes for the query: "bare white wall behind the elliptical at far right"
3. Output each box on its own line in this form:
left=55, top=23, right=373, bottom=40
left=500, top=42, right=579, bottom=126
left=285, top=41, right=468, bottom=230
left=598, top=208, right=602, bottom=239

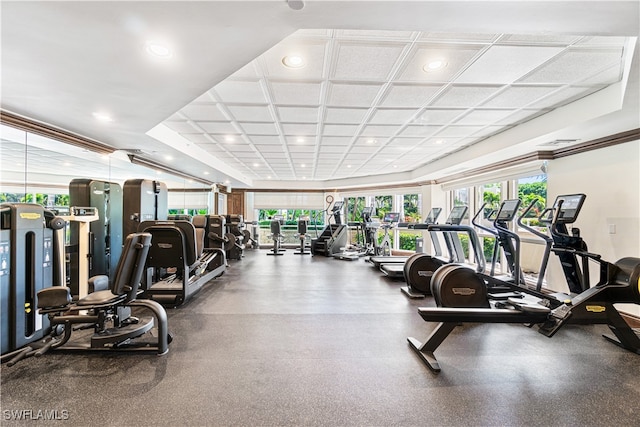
left=547, top=141, right=640, bottom=315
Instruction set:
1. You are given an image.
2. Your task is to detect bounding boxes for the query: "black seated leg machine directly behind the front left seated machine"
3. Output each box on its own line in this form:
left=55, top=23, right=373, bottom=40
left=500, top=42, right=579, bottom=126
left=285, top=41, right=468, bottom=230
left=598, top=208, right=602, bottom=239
left=139, top=215, right=227, bottom=307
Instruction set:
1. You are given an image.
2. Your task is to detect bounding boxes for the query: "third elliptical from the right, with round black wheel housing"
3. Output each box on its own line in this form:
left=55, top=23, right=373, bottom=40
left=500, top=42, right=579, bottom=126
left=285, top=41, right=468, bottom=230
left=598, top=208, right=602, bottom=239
left=392, top=205, right=468, bottom=298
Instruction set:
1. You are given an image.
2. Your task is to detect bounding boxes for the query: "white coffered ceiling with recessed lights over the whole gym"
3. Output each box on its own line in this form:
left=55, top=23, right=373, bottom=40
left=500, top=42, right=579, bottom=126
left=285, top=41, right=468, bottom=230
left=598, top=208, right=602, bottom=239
left=0, top=0, right=640, bottom=189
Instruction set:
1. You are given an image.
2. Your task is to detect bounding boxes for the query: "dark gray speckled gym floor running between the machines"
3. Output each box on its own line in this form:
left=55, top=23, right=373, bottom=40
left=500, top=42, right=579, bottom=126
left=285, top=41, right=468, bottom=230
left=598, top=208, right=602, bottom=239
left=0, top=250, right=640, bottom=426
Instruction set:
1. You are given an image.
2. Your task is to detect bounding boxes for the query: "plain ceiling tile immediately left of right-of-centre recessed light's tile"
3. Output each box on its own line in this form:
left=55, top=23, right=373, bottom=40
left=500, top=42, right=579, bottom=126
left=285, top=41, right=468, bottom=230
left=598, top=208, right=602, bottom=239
left=331, top=42, right=405, bottom=81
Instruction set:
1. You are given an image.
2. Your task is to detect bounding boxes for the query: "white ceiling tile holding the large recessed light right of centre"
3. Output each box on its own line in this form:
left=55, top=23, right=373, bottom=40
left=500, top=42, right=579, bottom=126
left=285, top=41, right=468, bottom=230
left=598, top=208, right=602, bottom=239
left=397, top=44, right=481, bottom=83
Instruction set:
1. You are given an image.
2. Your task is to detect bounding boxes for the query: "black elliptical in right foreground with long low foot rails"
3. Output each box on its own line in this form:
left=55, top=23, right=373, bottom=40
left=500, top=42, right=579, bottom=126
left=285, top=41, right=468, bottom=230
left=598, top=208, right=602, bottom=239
left=408, top=194, right=640, bottom=372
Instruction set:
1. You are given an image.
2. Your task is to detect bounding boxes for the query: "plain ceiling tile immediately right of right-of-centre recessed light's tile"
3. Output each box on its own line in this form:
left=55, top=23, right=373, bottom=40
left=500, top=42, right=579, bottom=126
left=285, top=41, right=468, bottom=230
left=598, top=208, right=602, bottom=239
left=455, top=46, right=563, bottom=84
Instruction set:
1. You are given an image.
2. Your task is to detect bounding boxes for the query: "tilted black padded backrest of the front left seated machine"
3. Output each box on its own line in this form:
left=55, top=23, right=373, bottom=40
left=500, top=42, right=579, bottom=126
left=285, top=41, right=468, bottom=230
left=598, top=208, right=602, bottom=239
left=110, top=233, right=151, bottom=301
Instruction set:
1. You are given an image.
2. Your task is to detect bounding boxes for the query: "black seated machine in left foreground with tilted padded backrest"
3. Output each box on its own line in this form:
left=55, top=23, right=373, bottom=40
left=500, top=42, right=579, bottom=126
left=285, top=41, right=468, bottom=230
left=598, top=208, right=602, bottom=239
left=2, top=233, right=171, bottom=366
